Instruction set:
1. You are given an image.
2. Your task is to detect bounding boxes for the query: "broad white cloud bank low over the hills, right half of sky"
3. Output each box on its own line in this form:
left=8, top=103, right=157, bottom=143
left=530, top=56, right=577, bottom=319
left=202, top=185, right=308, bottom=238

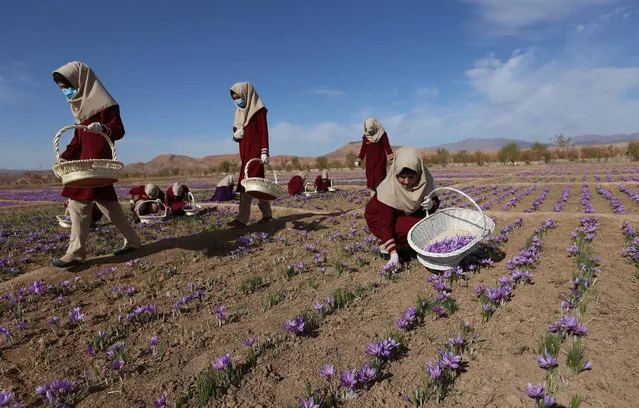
left=262, top=49, right=639, bottom=156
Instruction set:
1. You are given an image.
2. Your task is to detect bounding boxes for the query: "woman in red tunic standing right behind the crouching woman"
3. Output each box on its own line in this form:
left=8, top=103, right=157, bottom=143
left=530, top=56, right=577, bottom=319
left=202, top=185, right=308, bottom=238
left=355, top=118, right=393, bottom=193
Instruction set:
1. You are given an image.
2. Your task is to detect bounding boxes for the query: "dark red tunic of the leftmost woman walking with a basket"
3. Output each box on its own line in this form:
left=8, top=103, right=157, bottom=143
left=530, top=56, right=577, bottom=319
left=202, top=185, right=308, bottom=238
left=60, top=105, right=124, bottom=201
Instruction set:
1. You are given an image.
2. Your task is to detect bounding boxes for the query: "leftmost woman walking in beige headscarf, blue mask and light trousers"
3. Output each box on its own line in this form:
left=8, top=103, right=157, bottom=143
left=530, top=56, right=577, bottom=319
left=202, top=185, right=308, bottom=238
left=52, top=61, right=141, bottom=268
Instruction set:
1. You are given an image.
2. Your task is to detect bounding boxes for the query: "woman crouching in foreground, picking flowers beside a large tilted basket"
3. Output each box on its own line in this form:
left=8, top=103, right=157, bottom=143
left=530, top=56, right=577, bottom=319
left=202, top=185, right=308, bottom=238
left=364, top=147, right=439, bottom=265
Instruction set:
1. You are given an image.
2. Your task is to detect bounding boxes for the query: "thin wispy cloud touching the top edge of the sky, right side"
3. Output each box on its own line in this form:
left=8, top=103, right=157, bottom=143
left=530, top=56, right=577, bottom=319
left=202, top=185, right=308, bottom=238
left=463, top=0, right=621, bottom=36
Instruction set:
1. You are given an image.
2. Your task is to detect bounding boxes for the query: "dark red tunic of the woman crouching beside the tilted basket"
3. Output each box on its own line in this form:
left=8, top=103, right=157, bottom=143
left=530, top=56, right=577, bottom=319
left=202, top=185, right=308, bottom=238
left=364, top=194, right=439, bottom=254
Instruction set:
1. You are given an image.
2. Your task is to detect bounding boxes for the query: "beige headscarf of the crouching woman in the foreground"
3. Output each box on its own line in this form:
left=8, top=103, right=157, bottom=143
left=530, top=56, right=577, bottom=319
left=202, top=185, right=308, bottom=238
left=377, top=146, right=436, bottom=214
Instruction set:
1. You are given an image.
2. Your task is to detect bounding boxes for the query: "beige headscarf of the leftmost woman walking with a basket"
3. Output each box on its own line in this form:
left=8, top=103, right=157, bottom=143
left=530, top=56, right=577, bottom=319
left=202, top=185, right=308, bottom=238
left=54, top=61, right=118, bottom=124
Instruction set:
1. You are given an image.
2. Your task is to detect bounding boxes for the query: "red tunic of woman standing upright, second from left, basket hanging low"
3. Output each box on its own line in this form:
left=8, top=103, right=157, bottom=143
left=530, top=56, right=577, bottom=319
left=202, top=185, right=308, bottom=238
left=233, top=108, right=268, bottom=193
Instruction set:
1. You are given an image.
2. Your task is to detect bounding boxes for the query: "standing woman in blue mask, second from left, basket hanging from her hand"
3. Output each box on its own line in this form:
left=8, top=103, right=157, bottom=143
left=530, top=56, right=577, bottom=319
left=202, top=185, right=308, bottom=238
left=229, top=82, right=273, bottom=228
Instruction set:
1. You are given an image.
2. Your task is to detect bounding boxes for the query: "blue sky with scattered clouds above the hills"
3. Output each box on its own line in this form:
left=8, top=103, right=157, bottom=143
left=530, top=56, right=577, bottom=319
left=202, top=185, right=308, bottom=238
left=0, top=0, right=639, bottom=169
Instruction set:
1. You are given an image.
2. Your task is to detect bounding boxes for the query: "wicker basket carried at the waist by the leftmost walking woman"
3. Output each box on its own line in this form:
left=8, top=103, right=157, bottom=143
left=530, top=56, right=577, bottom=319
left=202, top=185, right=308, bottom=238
left=51, top=125, right=124, bottom=188
